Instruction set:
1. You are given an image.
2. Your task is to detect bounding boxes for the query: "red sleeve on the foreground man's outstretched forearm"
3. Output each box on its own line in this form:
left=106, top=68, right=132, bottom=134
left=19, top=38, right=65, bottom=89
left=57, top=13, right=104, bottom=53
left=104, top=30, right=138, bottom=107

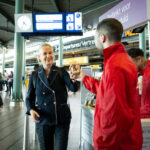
left=82, top=75, right=99, bottom=94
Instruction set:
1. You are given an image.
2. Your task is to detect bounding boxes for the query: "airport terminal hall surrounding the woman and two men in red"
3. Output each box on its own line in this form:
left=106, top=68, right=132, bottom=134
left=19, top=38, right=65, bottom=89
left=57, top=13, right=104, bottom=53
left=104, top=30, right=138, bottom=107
left=0, top=0, right=150, bottom=150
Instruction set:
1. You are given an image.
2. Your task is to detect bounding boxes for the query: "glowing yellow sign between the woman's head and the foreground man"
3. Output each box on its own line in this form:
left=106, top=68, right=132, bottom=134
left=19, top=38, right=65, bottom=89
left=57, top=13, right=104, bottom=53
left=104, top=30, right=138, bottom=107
left=63, top=56, right=89, bottom=66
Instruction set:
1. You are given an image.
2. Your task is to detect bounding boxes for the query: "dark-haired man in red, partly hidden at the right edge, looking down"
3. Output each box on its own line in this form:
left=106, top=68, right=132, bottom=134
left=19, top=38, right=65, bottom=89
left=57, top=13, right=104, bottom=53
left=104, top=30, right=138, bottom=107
left=128, top=48, right=150, bottom=118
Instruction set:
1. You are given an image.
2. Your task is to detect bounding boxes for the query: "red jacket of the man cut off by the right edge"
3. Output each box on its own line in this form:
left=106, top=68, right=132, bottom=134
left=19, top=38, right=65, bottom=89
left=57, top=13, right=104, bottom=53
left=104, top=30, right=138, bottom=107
left=140, top=61, right=150, bottom=118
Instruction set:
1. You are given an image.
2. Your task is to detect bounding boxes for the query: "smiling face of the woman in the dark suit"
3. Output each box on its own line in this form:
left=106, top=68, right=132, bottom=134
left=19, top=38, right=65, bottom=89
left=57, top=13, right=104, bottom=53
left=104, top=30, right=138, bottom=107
left=39, top=45, right=54, bottom=68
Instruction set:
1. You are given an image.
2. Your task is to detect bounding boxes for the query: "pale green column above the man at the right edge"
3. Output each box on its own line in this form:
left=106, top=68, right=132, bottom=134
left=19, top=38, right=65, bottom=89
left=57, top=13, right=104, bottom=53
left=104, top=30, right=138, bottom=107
left=139, top=30, right=146, bottom=58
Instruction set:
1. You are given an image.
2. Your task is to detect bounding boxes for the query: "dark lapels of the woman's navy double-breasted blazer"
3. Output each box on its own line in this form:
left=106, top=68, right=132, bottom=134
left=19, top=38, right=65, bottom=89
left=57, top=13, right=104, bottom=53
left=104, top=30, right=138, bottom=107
left=38, top=65, right=56, bottom=88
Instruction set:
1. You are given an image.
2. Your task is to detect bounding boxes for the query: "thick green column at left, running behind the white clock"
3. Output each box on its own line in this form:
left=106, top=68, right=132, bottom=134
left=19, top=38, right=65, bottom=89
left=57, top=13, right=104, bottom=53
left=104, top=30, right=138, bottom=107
left=12, top=0, right=24, bottom=102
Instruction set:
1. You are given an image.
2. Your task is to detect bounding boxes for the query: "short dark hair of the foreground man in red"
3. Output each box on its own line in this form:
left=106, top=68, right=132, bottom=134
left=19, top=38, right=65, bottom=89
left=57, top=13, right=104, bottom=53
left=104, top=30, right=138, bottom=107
left=97, top=18, right=123, bottom=42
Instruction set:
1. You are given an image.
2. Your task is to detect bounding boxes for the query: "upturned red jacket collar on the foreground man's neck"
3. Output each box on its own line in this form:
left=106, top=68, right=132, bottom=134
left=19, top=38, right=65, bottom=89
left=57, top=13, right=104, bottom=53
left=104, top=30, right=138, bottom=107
left=103, top=42, right=126, bottom=63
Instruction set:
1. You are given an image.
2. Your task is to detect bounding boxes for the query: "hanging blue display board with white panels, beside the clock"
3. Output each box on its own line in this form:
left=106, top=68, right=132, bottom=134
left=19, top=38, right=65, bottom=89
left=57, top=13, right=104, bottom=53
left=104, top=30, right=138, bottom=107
left=33, top=12, right=82, bottom=34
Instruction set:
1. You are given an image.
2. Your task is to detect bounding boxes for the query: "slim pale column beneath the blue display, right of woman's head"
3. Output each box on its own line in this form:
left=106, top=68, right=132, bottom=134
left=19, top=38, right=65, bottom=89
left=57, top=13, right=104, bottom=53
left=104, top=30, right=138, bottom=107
left=58, top=36, right=63, bottom=67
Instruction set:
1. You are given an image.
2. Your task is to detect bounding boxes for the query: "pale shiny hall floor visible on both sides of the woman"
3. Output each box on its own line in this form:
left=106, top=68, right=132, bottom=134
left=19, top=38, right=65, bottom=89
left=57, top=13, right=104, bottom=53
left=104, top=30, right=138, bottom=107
left=0, top=88, right=80, bottom=150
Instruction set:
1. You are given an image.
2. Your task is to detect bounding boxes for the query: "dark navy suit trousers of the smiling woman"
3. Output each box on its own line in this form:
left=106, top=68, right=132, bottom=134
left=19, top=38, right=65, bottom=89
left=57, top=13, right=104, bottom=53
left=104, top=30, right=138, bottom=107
left=36, top=124, right=70, bottom=150
